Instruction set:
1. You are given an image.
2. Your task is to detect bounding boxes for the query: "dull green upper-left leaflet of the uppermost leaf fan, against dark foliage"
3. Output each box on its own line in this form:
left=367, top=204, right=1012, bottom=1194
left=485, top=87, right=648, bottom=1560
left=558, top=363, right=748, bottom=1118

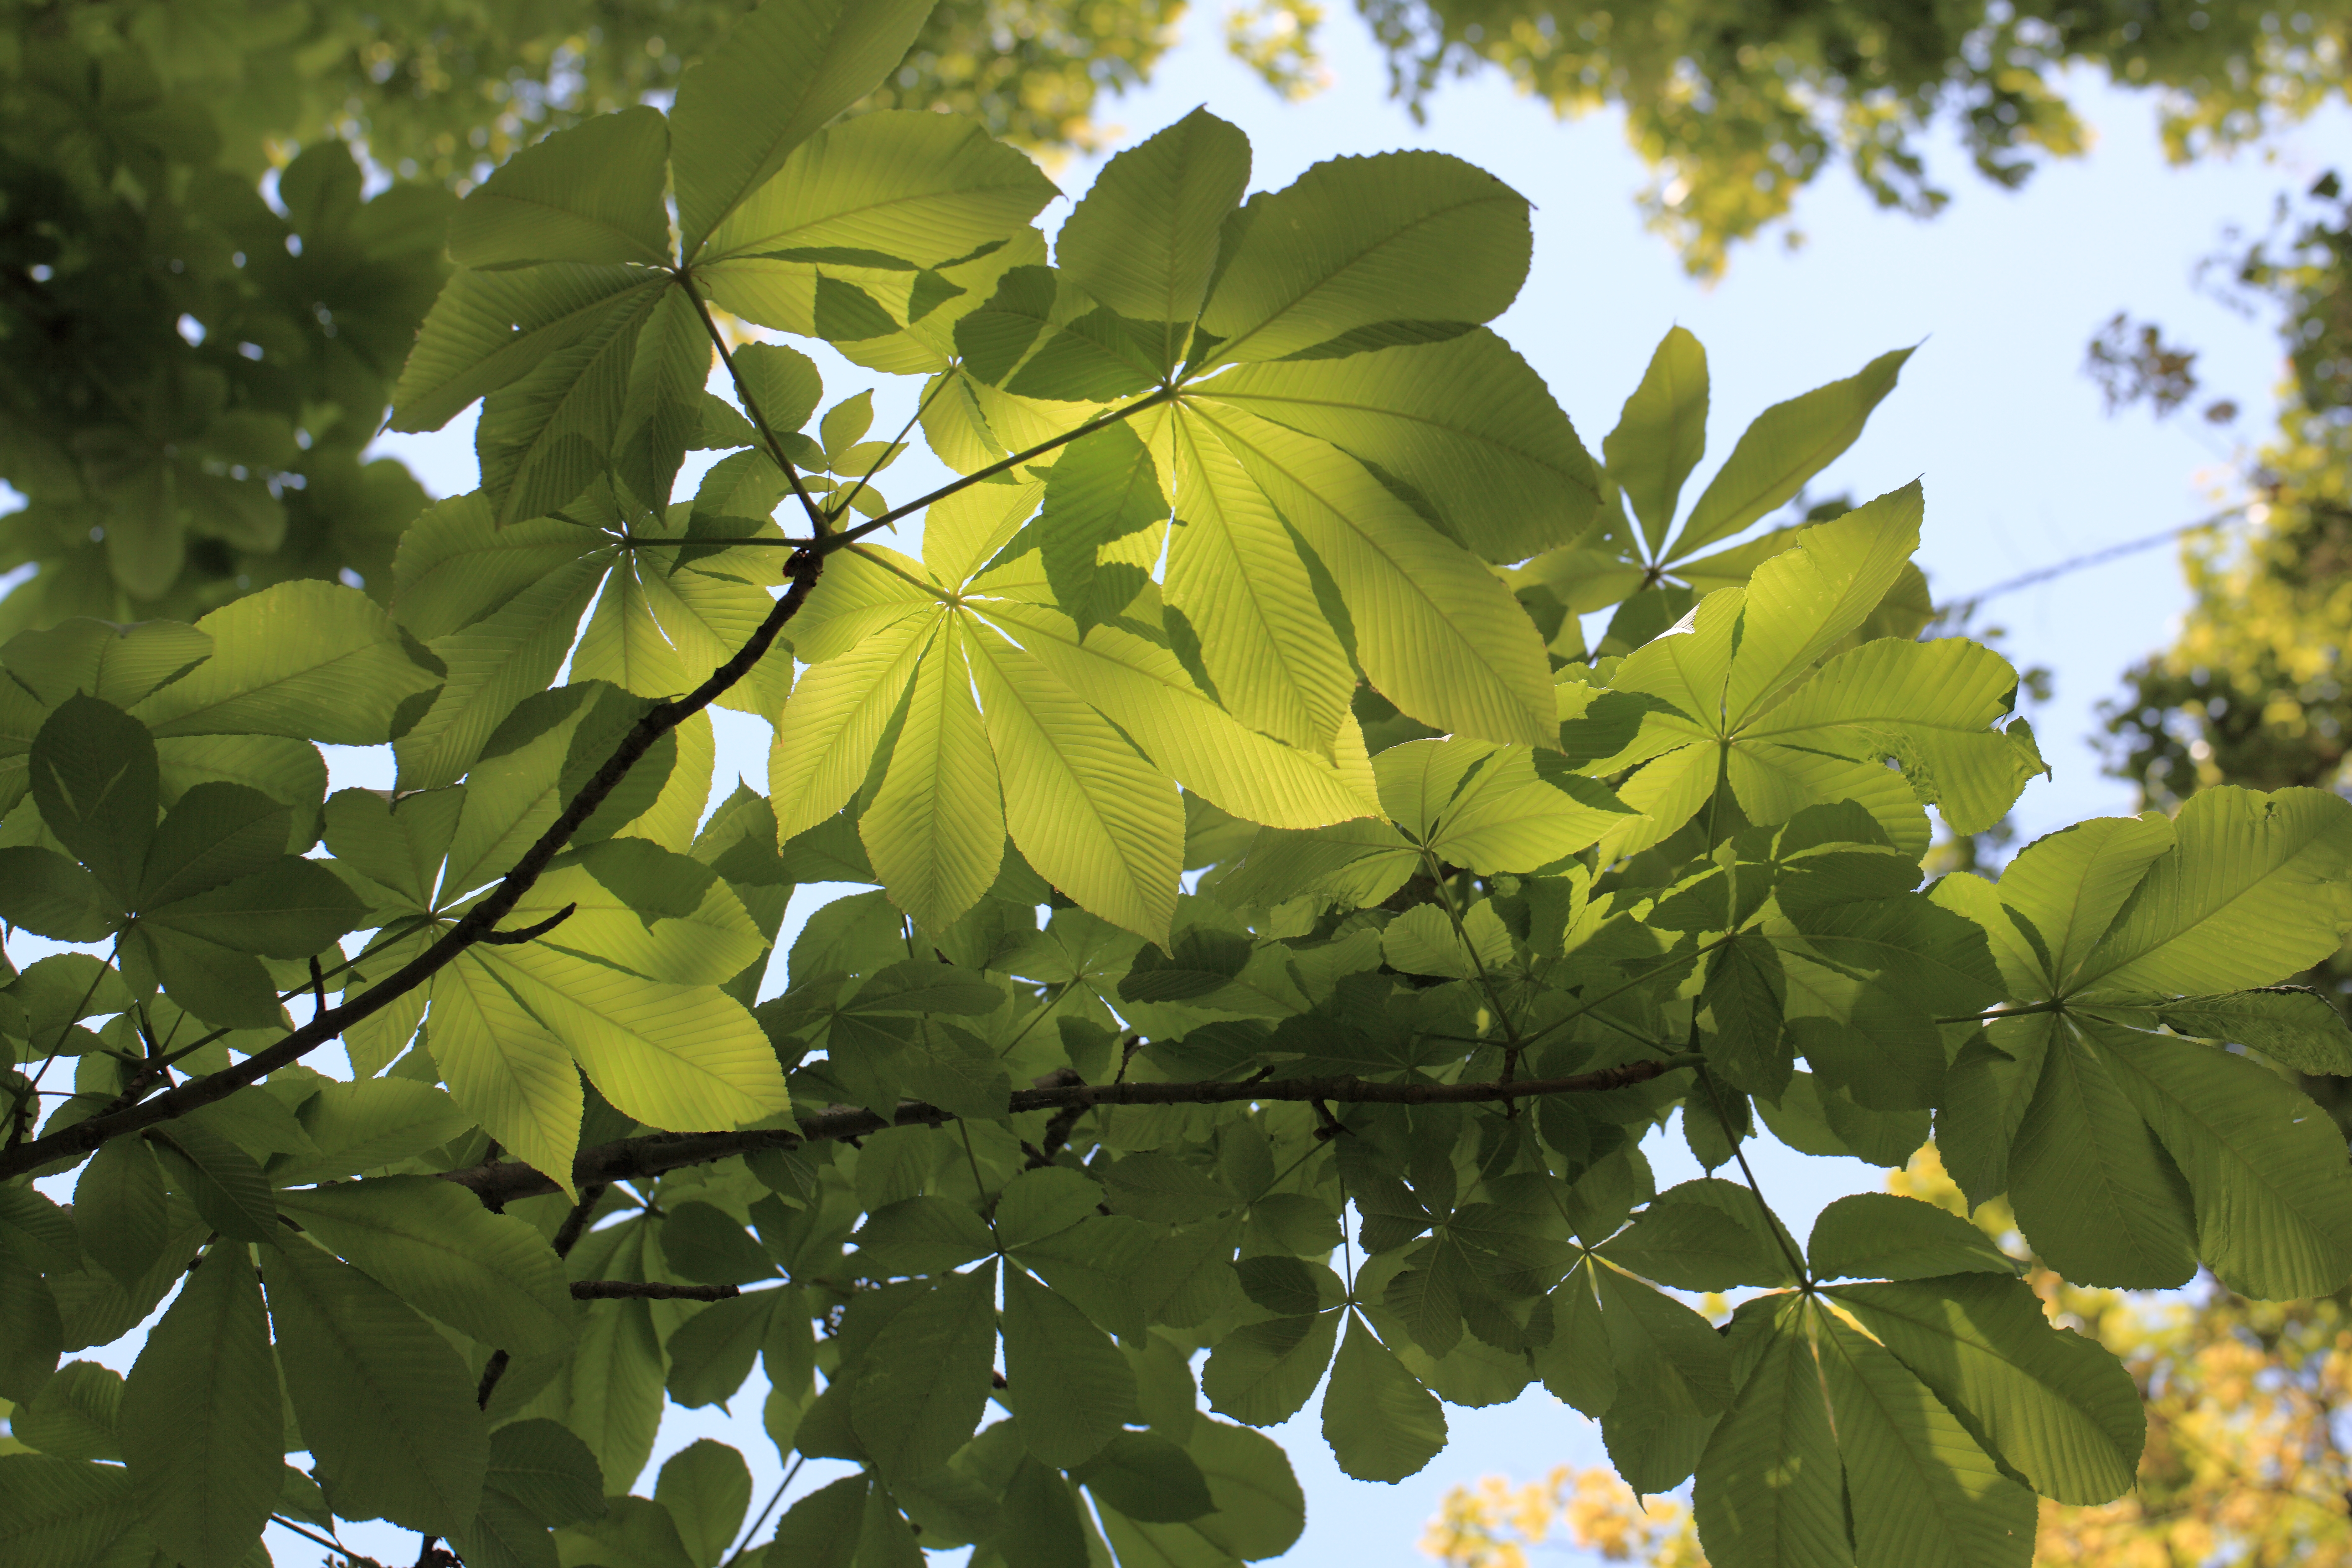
left=449, top=106, right=671, bottom=268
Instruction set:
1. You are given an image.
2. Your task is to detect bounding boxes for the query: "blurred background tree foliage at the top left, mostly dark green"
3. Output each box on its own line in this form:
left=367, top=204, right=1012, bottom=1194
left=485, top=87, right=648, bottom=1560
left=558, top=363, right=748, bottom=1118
left=0, top=0, right=1194, bottom=635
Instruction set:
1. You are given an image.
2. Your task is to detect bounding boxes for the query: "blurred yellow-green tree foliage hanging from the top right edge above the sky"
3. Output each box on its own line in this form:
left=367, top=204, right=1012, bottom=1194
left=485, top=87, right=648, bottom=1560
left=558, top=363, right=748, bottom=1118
left=1357, top=0, right=2352, bottom=275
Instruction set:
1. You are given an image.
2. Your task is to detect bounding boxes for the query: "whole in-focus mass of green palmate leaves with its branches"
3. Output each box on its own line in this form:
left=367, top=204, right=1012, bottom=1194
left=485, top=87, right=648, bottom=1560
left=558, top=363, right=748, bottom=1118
left=0, top=0, right=2352, bottom=1568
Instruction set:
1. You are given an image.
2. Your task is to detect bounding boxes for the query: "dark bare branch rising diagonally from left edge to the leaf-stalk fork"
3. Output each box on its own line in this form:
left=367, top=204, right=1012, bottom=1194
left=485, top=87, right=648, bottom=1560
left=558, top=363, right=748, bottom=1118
left=0, top=552, right=823, bottom=1192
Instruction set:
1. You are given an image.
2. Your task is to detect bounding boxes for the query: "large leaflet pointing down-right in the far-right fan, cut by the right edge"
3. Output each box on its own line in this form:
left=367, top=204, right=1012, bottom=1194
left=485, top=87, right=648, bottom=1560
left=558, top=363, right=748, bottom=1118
left=2084, top=1020, right=2352, bottom=1300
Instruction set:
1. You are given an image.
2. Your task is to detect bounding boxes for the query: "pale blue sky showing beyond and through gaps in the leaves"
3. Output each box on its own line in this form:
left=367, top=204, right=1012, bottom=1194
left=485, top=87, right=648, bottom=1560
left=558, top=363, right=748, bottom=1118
left=73, top=14, right=2345, bottom=1563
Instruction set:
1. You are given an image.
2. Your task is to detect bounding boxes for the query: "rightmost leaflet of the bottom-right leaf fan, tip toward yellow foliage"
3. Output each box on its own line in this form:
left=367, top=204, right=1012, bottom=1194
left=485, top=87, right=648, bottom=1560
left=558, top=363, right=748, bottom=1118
left=1828, top=1274, right=2147, bottom=1502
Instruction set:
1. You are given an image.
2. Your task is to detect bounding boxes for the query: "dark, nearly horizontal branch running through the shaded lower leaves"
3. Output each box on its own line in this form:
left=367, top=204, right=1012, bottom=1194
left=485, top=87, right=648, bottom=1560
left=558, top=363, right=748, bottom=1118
left=442, top=1055, right=1700, bottom=1204
